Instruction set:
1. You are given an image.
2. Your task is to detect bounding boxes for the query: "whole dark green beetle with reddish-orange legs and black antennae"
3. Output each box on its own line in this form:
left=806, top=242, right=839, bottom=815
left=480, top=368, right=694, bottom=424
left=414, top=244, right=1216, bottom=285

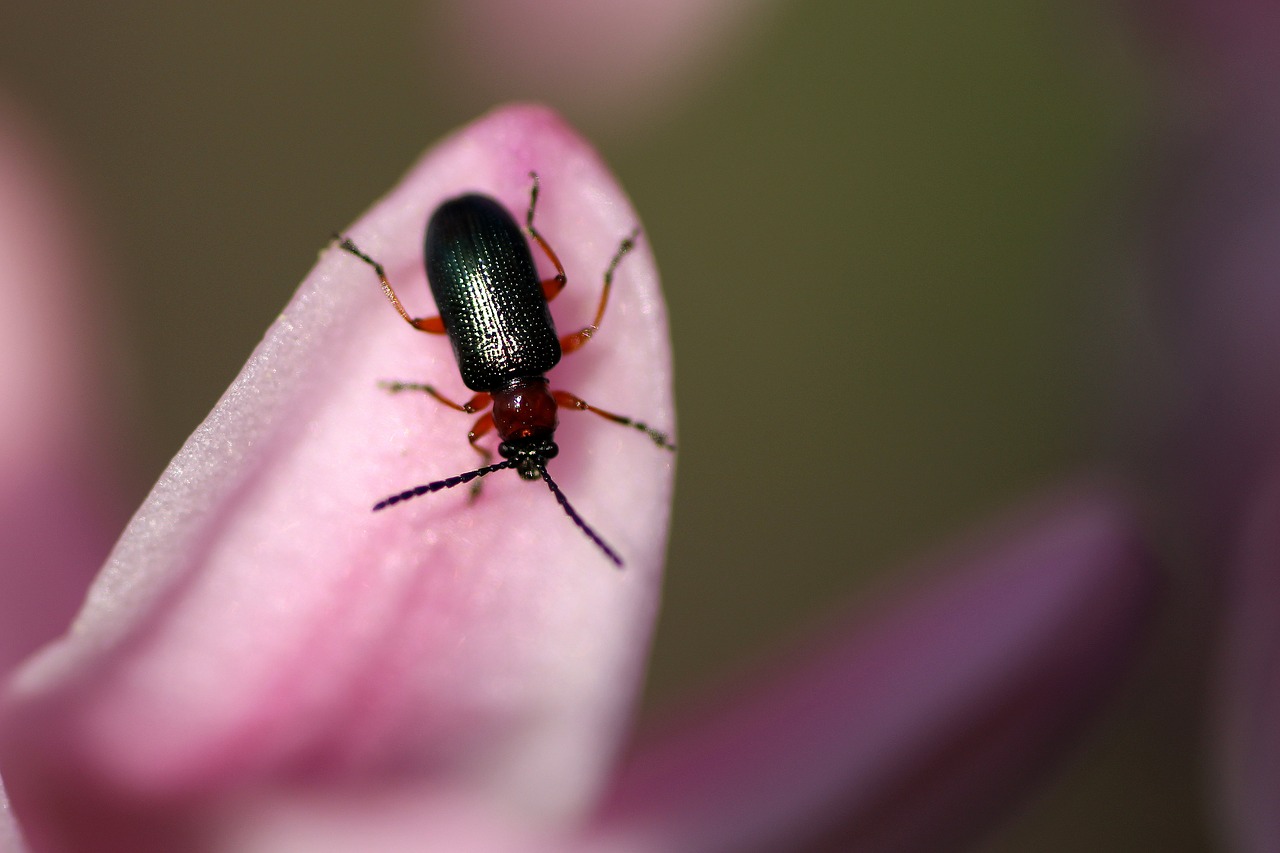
left=334, top=172, right=676, bottom=567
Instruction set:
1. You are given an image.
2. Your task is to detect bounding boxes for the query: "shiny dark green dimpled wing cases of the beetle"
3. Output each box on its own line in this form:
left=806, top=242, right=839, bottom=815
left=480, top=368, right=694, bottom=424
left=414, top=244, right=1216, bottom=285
left=424, top=195, right=561, bottom=391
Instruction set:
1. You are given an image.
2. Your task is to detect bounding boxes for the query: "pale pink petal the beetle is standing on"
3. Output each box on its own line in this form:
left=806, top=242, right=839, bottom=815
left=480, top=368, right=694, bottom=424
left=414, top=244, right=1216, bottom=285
left=0, top=106, right=673, bottom=850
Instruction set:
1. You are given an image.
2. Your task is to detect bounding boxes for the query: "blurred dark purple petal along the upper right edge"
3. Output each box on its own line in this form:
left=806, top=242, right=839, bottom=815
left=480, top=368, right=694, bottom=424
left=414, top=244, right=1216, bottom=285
left=1130, top=0, right=1280, bottom=548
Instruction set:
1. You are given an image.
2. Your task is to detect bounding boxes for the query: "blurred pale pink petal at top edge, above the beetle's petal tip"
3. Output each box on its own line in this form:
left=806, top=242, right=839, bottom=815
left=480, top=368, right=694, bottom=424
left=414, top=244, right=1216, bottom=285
left=426, top=0, right=774, bottom=132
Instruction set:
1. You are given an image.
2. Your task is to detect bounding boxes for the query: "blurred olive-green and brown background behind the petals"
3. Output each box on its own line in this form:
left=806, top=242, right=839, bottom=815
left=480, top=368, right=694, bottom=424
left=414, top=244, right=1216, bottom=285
left=0, top=0, right=1210, bottom=852
